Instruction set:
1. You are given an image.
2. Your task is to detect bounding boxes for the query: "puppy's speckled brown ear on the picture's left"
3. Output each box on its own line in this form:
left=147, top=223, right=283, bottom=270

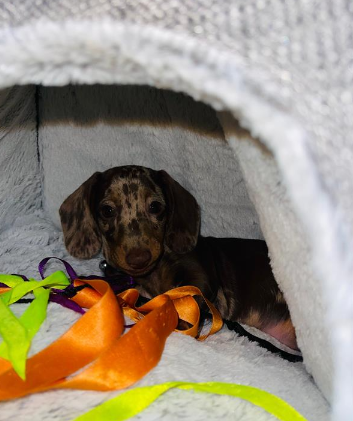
left=59, top=172, right=102, bottom=259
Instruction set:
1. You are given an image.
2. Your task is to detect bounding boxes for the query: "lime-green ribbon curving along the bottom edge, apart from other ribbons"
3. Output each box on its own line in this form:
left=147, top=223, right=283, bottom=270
left=73, top=382, right=307, bottom=421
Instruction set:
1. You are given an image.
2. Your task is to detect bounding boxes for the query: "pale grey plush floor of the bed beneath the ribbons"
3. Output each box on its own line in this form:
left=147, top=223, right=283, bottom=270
left=0, top=213, right=329, bottom=421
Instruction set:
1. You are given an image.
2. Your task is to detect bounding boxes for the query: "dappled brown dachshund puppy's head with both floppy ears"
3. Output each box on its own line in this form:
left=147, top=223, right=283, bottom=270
left=59, top=166, right=200, bottom=276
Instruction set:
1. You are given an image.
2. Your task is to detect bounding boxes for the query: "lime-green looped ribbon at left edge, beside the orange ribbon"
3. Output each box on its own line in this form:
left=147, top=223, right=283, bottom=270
left=0, top=271, right=70, bottom=380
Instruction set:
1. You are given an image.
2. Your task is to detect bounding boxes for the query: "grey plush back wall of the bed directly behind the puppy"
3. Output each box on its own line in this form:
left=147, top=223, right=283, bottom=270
left=39, top=85, right=262, bottom=238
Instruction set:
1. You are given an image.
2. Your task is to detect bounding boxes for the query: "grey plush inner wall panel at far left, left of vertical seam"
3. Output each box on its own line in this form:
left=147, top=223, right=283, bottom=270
left=0, top=86, right=41, bottom=233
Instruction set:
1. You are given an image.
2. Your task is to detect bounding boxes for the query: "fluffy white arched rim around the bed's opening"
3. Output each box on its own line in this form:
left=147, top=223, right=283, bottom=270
left=0, top=8, right=353, bottom=421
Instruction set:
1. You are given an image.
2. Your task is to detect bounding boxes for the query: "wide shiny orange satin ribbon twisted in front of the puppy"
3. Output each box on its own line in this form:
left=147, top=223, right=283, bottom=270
left=0, top=280, right=222, bottom=401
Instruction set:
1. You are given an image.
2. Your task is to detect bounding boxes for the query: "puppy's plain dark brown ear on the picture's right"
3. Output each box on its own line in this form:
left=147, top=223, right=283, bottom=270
left=158, top=170, right=200, bottom=254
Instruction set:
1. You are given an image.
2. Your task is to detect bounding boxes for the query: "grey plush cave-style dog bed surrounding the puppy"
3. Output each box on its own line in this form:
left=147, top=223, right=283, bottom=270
left=0, top=0, right=353, bottom=421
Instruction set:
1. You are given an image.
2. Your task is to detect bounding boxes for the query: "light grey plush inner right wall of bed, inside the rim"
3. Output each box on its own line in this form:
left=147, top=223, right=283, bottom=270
left=220, top=114, right=333, bottom=396
